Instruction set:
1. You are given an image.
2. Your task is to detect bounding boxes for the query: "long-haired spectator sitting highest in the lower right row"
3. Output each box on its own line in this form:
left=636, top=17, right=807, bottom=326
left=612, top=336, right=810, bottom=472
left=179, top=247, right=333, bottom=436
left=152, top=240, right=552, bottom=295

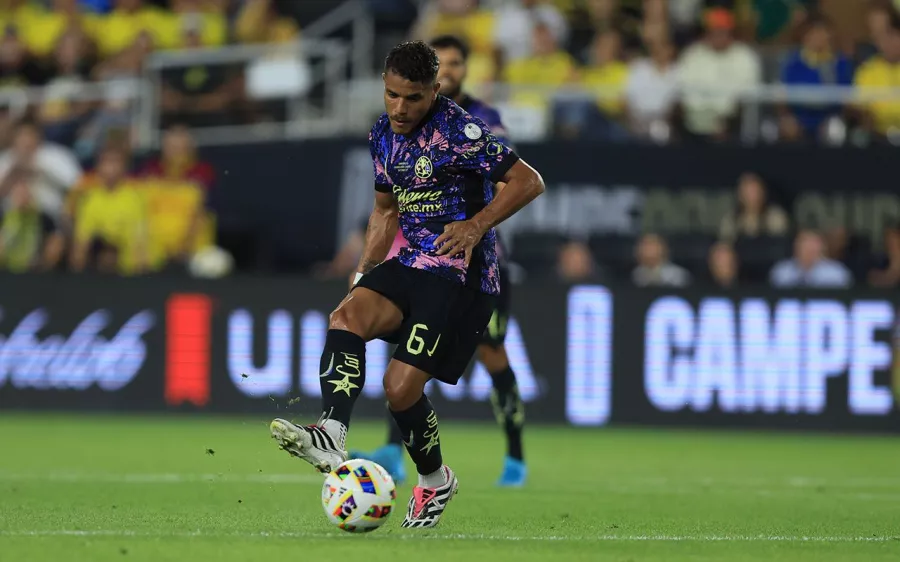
left=719, top=173, right=790, bottom=242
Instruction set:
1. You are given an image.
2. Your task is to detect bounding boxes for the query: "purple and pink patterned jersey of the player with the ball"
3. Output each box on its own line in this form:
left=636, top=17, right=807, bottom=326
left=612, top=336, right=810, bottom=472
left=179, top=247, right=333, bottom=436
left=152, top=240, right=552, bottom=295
left=369, top=96, right=518, bottom=295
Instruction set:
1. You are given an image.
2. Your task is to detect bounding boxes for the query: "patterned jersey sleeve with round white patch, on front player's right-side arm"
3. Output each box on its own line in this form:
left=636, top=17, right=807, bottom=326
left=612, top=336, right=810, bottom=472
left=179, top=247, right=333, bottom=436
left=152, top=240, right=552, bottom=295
left=450, top=114, right=519, bottom=183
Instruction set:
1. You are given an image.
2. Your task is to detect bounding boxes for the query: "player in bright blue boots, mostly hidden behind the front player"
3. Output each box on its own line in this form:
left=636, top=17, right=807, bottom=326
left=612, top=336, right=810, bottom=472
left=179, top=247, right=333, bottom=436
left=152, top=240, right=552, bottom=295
left=350, top=35, right=527, bottom=487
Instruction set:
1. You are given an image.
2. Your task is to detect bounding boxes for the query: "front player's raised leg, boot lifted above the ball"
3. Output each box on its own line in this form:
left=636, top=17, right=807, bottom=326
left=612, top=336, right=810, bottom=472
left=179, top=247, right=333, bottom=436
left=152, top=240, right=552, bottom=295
left=270, top=284, right=403, bottom=472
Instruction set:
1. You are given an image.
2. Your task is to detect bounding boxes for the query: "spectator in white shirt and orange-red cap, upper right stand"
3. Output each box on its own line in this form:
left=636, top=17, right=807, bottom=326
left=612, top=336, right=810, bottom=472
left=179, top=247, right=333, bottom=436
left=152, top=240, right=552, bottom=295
left=625, top=35, right=678, bottom=139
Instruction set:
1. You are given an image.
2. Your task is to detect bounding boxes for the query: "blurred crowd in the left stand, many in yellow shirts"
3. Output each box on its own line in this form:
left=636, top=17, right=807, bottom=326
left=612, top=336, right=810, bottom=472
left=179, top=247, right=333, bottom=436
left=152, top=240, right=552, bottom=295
left=0, top=0, right=299, bottom=275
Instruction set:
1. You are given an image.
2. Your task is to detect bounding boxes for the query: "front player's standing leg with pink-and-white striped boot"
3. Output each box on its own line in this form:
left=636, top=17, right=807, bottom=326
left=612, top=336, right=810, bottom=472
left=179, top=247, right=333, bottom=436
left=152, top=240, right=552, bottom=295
left=384, top=359, right=459, bottom=527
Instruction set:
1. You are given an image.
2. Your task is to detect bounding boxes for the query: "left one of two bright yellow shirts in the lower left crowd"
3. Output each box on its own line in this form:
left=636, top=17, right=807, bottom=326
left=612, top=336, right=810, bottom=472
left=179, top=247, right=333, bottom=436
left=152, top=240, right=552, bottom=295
left=75, top=180, right=147, bottom=275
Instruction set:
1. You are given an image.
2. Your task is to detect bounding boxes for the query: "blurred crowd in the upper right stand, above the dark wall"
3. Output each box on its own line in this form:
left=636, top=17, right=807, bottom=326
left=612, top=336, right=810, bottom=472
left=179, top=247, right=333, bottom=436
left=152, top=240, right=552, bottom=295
left=398, top=0, right=900, bottom=144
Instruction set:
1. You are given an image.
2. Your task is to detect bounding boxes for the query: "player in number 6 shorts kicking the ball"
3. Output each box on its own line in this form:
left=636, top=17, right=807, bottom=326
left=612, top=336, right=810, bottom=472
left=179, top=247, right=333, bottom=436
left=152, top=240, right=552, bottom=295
left=270, top=41, right=544, bottom=527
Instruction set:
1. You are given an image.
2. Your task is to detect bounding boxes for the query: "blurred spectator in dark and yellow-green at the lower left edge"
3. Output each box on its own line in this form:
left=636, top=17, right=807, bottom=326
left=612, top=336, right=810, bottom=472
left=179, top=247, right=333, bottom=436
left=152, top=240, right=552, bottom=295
left=0, top=171, right=65, bottom=273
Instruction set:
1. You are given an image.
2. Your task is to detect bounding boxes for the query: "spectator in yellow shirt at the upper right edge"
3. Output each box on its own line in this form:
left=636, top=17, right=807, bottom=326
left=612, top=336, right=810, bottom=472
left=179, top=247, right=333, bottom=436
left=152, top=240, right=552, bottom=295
left=854, top=9, right=900, bottom=141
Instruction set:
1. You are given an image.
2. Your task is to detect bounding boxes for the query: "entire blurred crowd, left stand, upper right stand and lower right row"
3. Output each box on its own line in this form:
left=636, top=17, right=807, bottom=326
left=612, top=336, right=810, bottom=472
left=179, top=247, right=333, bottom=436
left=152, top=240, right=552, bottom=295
left=0, top=0, right=900, bottom=286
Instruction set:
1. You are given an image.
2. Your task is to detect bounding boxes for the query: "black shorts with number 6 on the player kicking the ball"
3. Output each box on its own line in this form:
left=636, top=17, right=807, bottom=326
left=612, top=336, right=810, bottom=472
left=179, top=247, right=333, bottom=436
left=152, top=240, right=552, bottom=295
left=356, top=259, right=496, bottom=384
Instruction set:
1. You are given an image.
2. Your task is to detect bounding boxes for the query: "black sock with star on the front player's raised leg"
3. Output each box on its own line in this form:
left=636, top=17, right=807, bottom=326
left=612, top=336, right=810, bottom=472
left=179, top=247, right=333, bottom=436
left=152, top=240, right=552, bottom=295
left=319, top=330, right=366, bottom=427
